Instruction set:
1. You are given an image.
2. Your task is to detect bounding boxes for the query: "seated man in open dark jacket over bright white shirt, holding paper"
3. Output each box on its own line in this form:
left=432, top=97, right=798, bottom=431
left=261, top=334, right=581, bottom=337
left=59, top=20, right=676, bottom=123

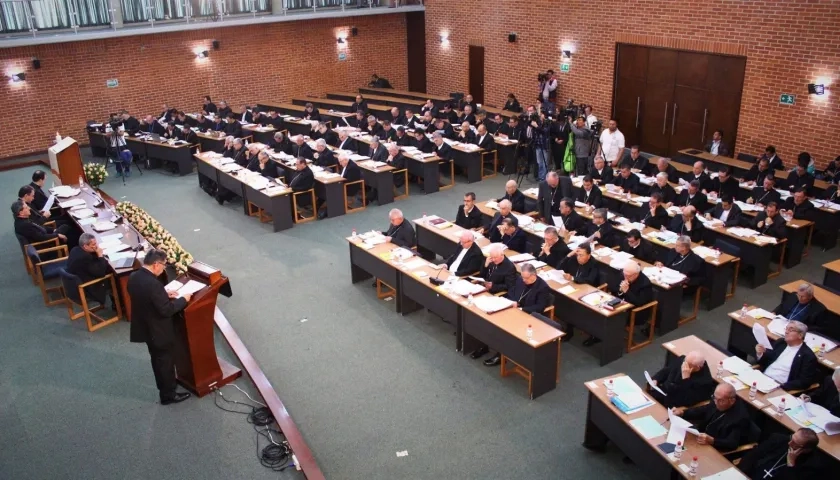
left=755, top=320, right=819, bottom=390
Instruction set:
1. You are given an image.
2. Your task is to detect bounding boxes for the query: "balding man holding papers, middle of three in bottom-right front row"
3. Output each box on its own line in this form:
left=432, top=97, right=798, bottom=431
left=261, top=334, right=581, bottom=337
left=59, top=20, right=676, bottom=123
left=673, top=383, right=752, bottom=452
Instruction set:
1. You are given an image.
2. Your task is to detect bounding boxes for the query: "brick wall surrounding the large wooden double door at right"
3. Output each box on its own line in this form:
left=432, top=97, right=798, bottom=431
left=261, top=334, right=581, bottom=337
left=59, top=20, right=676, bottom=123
left=426, top=0, right=840, bottom=169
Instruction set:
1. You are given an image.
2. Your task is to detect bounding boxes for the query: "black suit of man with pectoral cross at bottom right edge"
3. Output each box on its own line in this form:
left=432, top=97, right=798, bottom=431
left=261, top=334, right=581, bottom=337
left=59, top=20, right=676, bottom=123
left=738, top=433, right=830, bottom=480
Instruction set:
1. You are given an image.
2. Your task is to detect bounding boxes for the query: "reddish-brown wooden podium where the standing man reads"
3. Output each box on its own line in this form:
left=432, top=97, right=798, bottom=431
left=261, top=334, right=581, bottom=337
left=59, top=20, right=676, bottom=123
left=175, top=262, right=242, bottom=397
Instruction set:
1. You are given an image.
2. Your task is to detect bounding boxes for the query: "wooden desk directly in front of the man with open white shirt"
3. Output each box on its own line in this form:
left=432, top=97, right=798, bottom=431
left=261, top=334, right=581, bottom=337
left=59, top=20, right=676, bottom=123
left=662, top=335, right=840, bottom=460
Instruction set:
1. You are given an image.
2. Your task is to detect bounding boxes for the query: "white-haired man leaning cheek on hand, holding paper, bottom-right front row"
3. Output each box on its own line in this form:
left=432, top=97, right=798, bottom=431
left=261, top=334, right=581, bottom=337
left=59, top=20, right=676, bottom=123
left=650, top=351, right=716, bottom=407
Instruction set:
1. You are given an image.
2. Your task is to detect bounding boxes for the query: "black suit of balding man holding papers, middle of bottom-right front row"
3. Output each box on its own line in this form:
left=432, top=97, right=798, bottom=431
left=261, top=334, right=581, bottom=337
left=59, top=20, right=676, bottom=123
left=683, top=399, right=751, bottom=452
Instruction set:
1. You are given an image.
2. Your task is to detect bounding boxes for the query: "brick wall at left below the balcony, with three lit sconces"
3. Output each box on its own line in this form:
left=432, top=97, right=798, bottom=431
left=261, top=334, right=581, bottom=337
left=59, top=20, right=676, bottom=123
left=0, top=14, right=408, bottom=158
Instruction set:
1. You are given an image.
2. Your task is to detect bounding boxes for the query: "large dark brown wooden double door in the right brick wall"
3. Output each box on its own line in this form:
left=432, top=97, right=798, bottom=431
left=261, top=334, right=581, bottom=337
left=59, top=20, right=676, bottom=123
left=613, top=44, right=747, bottom=157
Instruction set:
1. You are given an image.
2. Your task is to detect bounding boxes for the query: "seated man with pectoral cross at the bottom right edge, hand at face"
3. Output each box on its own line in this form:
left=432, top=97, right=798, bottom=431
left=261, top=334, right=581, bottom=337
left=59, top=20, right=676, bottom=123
left=738, top=427, right=830, bottom=480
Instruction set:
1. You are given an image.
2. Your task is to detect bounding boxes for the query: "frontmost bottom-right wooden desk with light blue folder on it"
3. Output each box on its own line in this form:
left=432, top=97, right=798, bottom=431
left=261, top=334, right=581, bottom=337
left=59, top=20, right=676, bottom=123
left=583, top=373, right=733, bottom=480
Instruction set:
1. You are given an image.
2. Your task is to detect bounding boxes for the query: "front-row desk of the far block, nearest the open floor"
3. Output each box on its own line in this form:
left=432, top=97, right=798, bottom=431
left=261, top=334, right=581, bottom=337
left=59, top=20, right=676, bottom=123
left=195, top=152, right=294, bottom=232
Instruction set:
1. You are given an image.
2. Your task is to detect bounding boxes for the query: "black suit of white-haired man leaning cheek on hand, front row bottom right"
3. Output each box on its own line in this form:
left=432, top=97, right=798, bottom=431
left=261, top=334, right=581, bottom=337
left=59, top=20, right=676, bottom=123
left=648, top=354, right=717, bottom=408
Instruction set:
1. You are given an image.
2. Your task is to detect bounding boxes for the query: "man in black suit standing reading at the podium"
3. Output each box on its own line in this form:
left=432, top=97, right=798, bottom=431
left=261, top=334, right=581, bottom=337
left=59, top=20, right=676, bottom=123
left=128, top=249, right=191, bottom=405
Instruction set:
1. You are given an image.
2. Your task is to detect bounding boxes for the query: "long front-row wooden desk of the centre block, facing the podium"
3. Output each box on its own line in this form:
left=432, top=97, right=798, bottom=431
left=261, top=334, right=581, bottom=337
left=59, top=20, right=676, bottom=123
left=347, top=237, right=563, bottom=399
